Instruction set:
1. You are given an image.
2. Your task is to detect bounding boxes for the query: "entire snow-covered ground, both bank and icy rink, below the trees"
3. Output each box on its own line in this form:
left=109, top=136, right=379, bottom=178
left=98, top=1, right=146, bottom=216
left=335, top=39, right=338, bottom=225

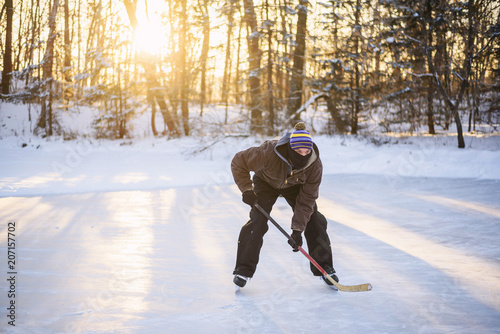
left=0, top=101, right=500, bottom=334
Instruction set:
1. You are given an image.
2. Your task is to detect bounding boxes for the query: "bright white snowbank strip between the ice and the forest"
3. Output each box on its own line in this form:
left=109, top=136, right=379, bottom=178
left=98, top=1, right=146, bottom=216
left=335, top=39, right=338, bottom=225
left=0, top=100, right=500, bottom=196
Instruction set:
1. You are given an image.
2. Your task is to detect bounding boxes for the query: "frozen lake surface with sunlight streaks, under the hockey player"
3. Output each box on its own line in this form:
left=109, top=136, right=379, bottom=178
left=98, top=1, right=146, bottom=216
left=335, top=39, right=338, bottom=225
left=0, top=174, right=500, bottom=334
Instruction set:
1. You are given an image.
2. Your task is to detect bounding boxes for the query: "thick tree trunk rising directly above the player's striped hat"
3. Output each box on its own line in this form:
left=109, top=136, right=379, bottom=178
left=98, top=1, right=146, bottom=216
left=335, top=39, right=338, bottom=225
left=287, top=0, right=308, bottom=126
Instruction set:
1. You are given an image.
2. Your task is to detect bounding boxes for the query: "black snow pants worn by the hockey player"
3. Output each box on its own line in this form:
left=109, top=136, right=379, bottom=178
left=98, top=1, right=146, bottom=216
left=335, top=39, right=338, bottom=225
left=234, top=176, right=333, bottom=277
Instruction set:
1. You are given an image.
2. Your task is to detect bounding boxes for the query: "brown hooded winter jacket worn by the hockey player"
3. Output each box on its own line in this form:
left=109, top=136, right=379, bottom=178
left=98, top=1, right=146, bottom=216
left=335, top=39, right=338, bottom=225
left=231, top=133, right=323, bottom=231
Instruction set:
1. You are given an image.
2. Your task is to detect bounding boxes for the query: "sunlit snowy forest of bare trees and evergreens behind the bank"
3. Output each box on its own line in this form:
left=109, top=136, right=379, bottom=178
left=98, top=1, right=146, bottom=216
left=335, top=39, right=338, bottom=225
left=0, top=0, right=500, bottom=148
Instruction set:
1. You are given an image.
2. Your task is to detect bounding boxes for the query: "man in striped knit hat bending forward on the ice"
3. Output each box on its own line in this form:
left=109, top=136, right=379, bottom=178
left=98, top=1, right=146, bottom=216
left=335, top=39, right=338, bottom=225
left=231, top=122, right=339, bottom=287
